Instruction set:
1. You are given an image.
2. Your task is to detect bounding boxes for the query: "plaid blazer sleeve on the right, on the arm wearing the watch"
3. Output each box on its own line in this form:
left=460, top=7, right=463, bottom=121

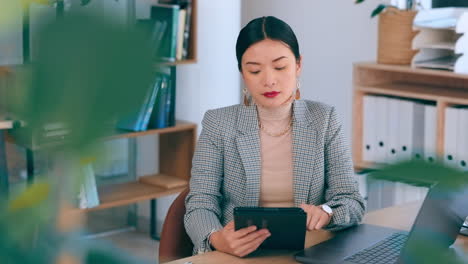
left=324, top=108, right=365, bottom=231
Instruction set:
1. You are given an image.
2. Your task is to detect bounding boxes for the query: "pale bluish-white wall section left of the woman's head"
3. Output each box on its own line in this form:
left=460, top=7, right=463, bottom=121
left=176, top=0, right=241, bottom=127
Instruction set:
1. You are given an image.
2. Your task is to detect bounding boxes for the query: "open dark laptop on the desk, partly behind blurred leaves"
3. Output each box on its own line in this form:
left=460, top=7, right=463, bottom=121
left=295, top=185, right=468, bottom=264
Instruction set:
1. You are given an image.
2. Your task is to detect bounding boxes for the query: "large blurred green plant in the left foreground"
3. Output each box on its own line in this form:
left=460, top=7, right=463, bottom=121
left=0, top=5, right=153, bottom=264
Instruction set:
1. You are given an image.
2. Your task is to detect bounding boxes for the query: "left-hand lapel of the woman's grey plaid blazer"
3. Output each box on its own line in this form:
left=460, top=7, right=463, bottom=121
left=236, top=105, right=262, bottom=206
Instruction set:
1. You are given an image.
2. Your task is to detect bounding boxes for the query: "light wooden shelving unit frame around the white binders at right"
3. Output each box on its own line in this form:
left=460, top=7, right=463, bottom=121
left=353, top=63, right=468, bottom=170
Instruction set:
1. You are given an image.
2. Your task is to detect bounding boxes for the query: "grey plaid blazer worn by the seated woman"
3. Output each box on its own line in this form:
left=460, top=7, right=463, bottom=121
left=184, top=100, right=365, bottom=253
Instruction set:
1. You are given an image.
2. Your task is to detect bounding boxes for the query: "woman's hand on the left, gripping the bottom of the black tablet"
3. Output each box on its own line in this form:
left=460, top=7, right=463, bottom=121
left=210, top=221, right=271, bottom=257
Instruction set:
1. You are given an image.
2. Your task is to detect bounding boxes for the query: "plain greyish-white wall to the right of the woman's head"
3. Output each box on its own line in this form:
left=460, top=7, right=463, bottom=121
left=242, top=0, right=380, bottom=138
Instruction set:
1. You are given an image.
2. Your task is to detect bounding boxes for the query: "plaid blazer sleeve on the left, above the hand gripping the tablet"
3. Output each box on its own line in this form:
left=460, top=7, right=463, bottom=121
left=184, top=110, right=224, bottom=254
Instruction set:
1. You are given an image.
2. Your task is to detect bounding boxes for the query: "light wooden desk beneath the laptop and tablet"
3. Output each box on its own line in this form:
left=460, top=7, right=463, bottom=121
left=167, top=202, right=468, bottom=264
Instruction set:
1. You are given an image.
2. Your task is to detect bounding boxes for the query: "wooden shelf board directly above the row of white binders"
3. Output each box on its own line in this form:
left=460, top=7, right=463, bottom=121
left=356, top=82, right=468, bottom=104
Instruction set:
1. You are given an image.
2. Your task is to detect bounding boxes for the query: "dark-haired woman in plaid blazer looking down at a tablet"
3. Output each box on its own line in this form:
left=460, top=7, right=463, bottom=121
left=185, top=16, right=364, bottom=256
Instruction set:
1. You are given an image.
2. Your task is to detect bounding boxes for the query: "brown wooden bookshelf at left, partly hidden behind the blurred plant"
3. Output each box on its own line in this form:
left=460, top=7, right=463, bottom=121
left=0, top=0, right=198, bottom=241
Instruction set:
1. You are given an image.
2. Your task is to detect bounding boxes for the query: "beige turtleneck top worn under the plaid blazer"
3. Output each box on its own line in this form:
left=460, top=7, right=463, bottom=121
left=257, top=103, right=294, bottom=207
